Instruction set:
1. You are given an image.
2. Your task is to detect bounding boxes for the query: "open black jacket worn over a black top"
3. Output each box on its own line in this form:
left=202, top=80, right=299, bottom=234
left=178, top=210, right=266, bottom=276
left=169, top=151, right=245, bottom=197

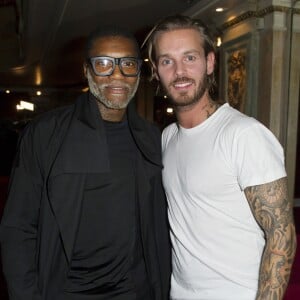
left=0, top=94, right=170, bottom=300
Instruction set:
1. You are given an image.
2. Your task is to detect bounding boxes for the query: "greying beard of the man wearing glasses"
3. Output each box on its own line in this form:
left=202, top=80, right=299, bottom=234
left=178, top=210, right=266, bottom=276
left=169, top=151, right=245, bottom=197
left=87, top=69, right=140, bottom=109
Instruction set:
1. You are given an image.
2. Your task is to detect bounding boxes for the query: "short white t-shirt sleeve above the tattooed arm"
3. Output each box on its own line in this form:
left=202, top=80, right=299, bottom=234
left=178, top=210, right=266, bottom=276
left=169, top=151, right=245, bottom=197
left=232, top=122, right=286, bottom=190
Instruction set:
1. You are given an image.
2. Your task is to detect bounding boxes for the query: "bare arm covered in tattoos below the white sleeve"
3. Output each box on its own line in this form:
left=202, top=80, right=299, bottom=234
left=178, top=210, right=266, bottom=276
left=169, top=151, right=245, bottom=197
left=245, top=178, right=296, bottom=300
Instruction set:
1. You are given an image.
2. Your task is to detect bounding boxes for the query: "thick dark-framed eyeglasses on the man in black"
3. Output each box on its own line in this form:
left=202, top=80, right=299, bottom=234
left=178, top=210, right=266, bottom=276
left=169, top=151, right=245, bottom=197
left=88, top=56, right=142, bottom=77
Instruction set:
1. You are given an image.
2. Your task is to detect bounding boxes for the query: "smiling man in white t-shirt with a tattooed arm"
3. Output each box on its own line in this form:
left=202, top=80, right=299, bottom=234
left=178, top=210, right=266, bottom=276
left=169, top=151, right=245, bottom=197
left=144, top=15, right=296, bottom=300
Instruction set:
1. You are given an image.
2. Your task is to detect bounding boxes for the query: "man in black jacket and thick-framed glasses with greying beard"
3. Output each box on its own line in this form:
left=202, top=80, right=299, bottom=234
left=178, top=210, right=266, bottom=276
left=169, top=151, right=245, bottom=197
left=1, top=28, right=170, bottom=300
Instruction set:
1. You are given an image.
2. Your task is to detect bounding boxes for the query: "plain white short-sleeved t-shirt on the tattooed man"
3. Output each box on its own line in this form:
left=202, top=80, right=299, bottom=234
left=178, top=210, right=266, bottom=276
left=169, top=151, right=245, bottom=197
left=162, top=103, right=286, bottom=300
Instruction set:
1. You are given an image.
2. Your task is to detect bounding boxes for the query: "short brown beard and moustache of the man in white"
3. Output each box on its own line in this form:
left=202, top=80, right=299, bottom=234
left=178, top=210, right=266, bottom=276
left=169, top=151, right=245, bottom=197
left=164, top=74, right=208, bottom=109
